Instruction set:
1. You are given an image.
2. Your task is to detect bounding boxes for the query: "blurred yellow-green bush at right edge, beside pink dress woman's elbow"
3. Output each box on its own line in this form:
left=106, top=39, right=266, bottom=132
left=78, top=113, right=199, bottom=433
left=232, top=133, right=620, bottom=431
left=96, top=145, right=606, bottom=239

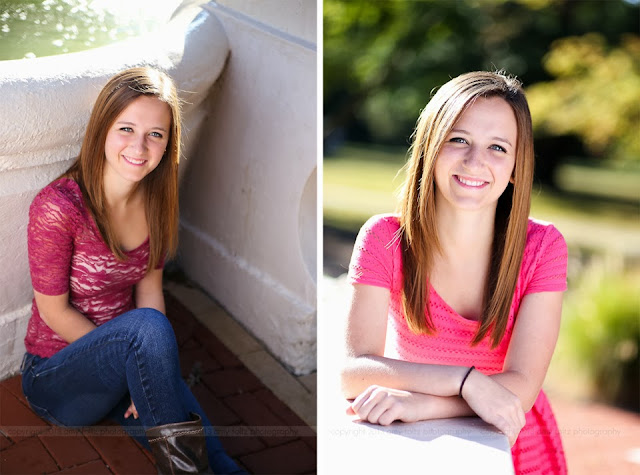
left=560, top=266, right=640, bottom=411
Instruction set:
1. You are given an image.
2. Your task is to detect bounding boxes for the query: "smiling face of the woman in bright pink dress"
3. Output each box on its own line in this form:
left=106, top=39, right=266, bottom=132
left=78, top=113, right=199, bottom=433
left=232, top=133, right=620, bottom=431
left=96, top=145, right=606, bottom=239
left=435, top=97, right=518, bottom=215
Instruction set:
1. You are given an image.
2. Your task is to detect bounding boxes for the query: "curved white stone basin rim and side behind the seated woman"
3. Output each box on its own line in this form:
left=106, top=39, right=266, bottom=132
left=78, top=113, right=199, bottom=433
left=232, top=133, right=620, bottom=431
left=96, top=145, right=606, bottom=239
left=0, top=0, right=229, bottom=379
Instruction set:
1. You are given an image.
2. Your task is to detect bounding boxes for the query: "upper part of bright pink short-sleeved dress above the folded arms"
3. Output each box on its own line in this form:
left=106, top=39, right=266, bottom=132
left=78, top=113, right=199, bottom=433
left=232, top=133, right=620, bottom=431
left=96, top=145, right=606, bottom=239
left=348, top=215, right=567, bottom=374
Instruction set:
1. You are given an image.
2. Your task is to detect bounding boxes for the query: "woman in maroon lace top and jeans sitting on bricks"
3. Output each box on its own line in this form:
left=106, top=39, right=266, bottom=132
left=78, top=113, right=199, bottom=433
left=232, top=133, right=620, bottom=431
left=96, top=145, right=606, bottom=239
left=22, top=68, right=244, bottom=473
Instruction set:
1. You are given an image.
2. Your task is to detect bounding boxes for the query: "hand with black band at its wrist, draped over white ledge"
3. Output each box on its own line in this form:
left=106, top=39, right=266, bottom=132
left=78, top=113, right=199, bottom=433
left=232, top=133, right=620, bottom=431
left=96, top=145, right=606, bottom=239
left=462, top=370, right=526, bottom=447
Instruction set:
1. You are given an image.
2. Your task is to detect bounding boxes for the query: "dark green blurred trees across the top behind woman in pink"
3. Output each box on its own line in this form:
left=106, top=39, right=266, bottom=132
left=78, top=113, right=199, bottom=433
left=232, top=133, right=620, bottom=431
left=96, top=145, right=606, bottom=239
left=324, top=0, right=640, bottom=169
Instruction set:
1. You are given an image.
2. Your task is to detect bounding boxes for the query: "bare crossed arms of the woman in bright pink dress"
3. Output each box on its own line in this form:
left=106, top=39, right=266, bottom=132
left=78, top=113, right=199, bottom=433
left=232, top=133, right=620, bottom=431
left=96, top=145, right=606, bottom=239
left=341, top=284, right=562, bottom=445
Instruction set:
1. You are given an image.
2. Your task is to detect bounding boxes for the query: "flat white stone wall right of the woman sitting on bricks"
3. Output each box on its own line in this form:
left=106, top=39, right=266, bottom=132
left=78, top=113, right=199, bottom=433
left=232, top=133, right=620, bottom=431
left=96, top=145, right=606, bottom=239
left=180, top=0, right=317, bottom=374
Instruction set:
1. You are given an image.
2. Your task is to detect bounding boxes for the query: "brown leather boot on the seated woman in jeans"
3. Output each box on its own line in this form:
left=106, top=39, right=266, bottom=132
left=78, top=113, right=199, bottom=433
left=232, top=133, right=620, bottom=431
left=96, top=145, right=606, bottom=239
left=146, top=412, right=212, bottom=474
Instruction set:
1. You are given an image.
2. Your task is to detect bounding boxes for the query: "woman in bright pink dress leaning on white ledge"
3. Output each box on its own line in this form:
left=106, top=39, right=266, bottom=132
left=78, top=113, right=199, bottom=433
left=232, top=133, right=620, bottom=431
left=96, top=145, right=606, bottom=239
left=341, top=72, right=567, bottom=474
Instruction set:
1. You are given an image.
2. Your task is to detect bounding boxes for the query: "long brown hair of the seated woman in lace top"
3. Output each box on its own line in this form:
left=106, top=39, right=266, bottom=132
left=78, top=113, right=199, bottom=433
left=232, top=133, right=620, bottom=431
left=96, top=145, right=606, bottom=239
left=63, top=67, right=181, bottom=272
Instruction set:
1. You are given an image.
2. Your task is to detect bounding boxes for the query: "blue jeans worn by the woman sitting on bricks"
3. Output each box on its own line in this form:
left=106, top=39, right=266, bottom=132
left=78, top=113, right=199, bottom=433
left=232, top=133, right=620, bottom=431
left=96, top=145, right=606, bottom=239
left=22, top=308, right=242, bottom=473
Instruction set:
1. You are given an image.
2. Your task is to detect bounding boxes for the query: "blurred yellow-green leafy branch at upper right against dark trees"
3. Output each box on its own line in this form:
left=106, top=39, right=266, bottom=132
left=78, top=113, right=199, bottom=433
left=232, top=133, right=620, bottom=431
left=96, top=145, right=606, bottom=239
left=527, top=33, right=640, bottom=160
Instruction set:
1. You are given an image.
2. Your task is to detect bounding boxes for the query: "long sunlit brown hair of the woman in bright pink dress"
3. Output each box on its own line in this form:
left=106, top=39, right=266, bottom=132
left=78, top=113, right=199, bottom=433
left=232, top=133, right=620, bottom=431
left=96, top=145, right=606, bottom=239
left=398, top=72, right=534, bottom=347
